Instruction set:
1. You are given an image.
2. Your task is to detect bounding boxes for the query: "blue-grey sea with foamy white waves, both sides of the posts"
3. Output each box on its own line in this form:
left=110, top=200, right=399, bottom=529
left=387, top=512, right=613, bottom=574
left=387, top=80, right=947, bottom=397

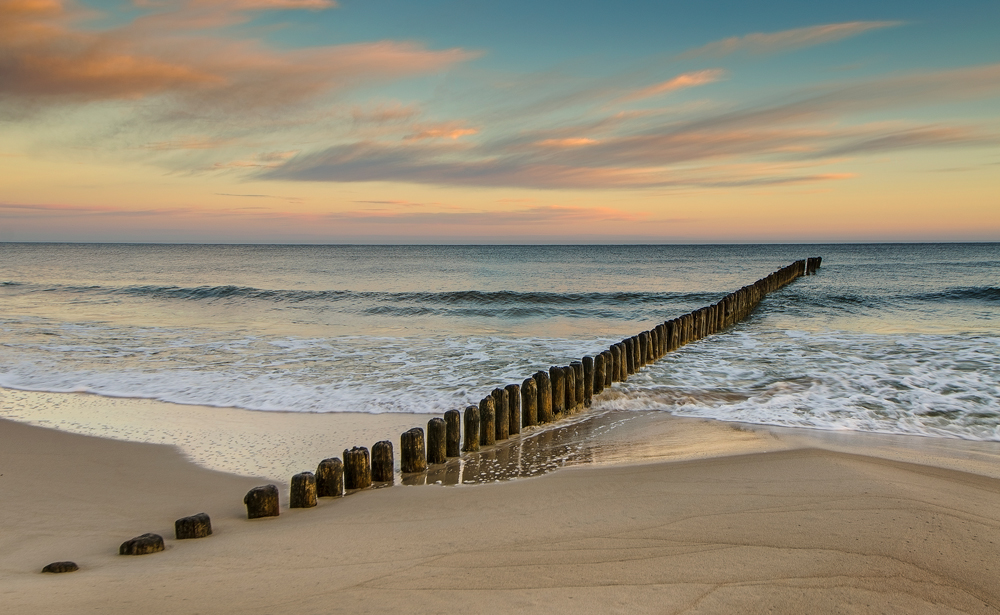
left=0, top=243, right=1000, bottom=441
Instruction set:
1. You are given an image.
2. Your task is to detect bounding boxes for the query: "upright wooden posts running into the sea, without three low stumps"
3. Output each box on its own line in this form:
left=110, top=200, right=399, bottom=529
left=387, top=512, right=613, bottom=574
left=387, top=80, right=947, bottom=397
left=244, top=257, right=822, bottom=519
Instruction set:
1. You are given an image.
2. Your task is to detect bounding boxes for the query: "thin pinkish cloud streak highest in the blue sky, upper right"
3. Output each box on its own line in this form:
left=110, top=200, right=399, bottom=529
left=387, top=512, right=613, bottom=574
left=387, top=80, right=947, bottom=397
left=678, top=21, right=903, bottom=59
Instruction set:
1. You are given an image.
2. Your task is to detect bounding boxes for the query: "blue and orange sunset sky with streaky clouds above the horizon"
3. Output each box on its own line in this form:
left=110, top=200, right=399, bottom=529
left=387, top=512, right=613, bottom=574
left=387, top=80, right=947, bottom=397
left=0, top=0, right=1000, bottom=243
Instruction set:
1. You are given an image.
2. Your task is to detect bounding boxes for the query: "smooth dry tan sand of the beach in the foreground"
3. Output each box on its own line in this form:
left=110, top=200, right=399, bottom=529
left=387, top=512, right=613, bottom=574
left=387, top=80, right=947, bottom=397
left=0, top=394, right=1000, bottom=614
